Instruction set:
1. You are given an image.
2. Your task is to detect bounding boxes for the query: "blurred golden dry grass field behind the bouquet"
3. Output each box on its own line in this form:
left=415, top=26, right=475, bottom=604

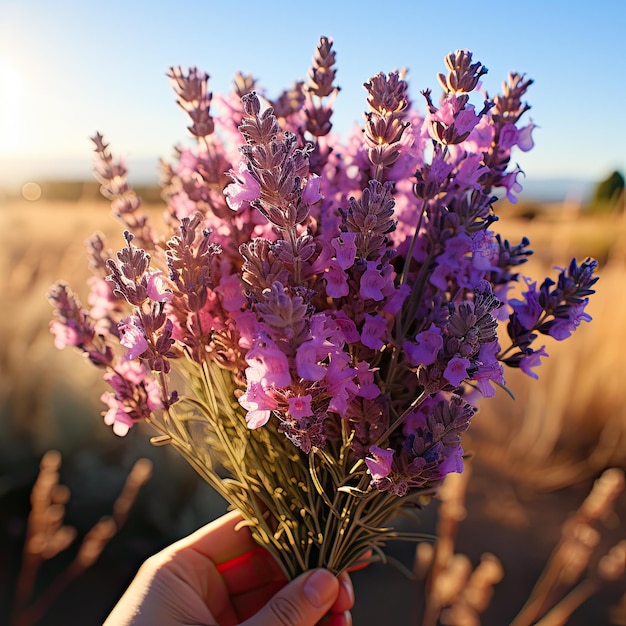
left=0, top=186, right=626, bottom=626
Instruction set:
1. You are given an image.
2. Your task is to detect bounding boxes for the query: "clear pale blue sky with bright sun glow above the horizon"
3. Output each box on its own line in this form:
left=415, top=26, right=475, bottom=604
left=0, top=0, right=626, bottom=193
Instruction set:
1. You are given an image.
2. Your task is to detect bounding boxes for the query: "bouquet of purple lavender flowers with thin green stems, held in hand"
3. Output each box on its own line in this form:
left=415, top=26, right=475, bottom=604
left=49, top=37, right=597, bottom=578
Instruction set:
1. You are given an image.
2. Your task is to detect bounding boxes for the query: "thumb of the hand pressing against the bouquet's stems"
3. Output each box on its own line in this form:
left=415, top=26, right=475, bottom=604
left=241, top=569, right=340, bottom=626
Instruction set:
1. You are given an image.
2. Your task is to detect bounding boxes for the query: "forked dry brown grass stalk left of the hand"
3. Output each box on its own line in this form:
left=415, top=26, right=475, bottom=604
left=11, top=451, right=152, bottom=626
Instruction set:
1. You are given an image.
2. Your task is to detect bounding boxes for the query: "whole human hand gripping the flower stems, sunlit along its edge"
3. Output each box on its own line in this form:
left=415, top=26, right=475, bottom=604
left=104, top=512, right=354, bottom=626
